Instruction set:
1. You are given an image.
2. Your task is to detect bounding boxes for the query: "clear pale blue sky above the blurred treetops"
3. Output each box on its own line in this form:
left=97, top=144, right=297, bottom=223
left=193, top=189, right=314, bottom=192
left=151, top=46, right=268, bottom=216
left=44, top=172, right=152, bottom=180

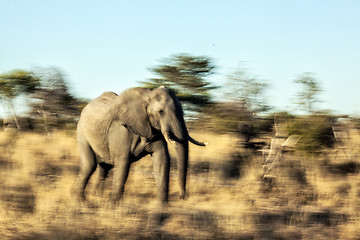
left=0, top=0, right=360, bottom=114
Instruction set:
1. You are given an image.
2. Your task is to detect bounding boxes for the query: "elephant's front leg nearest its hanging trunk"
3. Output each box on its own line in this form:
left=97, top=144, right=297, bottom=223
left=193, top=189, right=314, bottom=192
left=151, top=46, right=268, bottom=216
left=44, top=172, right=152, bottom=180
left=152, top=141, right=170, bottom=204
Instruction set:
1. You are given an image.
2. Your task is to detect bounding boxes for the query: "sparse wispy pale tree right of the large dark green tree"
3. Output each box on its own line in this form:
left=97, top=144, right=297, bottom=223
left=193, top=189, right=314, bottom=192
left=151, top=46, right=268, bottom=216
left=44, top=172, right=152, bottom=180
left=224, top=65, right=270, bottom=113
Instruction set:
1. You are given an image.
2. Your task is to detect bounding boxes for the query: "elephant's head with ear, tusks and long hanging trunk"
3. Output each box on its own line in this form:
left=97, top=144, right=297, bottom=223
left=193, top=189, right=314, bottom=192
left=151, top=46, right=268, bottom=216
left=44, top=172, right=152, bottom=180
left=114, top=87, right=205, bottom=198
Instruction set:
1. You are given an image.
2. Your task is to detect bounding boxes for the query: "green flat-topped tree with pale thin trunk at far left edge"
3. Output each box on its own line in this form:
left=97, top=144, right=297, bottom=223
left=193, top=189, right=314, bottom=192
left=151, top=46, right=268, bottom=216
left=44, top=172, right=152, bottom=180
left=0, top=70, right=40, bottom=130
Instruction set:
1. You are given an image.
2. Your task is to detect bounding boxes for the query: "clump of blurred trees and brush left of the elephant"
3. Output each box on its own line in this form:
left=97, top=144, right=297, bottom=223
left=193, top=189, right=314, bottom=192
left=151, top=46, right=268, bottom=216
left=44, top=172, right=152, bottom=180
left=0, top=67, right=87, bottom=132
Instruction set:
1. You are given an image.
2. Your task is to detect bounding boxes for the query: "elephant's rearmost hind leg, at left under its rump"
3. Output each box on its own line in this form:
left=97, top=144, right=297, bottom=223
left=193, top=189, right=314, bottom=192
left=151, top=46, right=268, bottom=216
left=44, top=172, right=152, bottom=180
left=72, top=134, right=97, bottom=201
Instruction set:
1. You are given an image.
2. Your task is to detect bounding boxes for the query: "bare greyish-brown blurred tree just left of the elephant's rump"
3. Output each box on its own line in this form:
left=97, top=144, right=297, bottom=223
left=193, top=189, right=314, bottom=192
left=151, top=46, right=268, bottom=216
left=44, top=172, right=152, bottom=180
left=30, top=67, right=83, bottom=131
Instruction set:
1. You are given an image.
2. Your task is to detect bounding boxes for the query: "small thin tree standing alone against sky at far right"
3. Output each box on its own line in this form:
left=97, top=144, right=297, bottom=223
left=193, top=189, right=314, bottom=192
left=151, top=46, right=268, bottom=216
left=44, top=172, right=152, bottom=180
left=294, top=72, right=321, bottom=114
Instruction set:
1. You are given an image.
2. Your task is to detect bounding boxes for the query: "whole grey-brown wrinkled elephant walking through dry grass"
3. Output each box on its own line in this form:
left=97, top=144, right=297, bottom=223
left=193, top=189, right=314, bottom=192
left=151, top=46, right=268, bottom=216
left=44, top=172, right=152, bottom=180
left=73, top=87, right=204, bottom=203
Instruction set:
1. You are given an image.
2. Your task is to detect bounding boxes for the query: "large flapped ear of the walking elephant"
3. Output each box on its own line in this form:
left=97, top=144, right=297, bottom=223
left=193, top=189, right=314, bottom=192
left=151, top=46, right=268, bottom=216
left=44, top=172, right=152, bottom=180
left=114, top=88, right=152, bottom=138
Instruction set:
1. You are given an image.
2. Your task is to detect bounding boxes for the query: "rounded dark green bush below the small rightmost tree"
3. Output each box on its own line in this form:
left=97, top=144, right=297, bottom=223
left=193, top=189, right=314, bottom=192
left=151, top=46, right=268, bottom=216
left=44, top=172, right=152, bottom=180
left=288, top=114, right=336, bottom=154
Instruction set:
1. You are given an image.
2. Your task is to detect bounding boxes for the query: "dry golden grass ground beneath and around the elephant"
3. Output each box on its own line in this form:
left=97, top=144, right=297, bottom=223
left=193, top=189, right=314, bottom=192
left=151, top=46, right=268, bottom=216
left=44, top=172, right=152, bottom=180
left=0, top=128, right=360, bottom=239
